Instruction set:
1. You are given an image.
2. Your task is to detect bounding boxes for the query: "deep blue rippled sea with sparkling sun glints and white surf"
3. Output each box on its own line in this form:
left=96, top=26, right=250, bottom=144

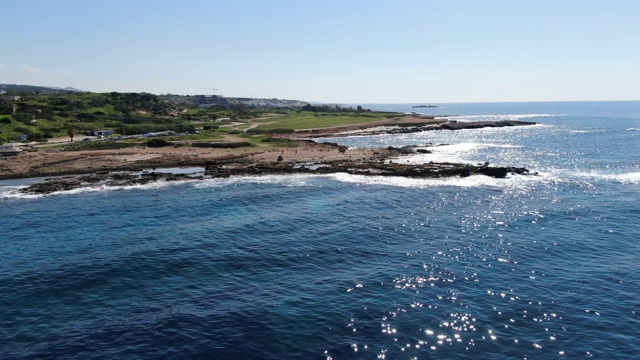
left=0, top=102, right=640, bottom=359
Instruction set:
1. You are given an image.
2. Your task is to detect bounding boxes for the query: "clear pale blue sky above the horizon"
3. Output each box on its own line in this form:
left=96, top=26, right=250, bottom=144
left=0, top=0, right=640, bottom=103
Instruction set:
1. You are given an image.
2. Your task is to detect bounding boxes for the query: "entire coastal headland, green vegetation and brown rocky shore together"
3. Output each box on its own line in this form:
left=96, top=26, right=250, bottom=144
left=0, top=86, right=534, bottom=193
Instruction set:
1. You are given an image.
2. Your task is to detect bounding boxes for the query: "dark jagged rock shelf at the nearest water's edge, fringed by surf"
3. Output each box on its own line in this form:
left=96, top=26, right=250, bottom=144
left=20, top=146, right=530, bottom=194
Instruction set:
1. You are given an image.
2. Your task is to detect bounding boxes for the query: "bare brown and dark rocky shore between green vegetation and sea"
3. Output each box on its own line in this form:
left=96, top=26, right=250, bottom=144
left=0, top=117, right=535, bottom=193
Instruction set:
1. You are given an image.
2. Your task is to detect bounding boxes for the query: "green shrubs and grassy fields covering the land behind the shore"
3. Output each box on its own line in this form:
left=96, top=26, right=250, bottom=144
left=0, top=87, right=400, bottom=149
